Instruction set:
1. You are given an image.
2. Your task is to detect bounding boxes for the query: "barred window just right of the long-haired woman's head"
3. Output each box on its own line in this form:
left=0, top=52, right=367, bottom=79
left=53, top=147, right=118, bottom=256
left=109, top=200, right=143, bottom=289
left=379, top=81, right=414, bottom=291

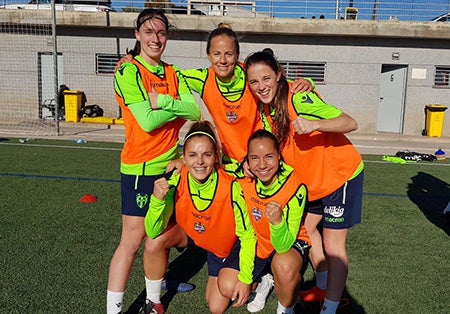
left=280, top=61, right=326, bottom=84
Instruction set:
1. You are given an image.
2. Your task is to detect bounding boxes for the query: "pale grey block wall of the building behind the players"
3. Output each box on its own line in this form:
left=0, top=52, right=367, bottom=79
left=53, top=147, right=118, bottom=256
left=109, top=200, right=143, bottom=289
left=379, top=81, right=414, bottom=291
left=0, top=11, right=450, bottom=136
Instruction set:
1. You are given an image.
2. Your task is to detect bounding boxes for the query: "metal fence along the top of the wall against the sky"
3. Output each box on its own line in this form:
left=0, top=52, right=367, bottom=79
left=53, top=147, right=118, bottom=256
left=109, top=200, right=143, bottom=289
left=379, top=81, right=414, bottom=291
left=0, top=0, right=450, bottom=22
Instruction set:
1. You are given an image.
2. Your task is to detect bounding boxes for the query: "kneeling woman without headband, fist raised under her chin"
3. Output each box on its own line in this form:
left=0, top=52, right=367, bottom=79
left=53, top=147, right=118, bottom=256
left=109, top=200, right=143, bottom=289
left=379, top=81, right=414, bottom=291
left=219, top=130, right=310, bottom=313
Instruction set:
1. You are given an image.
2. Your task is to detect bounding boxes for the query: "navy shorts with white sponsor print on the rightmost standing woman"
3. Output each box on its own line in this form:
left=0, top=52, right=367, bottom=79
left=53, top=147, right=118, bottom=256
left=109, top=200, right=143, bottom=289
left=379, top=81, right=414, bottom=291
left=306, top=171, right=364, bottom=230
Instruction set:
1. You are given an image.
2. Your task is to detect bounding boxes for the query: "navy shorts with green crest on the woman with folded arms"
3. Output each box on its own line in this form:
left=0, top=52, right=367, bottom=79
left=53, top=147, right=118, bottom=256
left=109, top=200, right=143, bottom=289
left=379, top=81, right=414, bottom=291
left=120, top=174, right=171, bottom=217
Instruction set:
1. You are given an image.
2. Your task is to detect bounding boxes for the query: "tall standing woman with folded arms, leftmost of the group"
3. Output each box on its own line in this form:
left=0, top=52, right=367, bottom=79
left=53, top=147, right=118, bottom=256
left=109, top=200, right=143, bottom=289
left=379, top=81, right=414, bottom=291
left=107, top=9, right=200, bottom=314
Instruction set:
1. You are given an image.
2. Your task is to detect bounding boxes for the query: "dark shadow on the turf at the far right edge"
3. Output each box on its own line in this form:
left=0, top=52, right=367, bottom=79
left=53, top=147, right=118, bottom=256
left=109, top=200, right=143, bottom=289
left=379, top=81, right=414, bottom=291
left=408, top=172, right=450, bottom=236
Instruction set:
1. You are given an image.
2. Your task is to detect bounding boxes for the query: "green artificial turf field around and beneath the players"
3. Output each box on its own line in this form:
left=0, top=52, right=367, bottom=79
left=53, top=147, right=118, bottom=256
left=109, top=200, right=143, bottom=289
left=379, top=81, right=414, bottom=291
left=0, top=138, right=450, bottom=314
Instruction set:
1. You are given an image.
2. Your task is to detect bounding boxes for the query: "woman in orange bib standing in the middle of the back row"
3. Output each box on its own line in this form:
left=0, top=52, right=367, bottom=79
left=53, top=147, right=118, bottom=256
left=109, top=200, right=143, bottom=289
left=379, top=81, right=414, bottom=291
left=181, top=23, right=313, bottom=176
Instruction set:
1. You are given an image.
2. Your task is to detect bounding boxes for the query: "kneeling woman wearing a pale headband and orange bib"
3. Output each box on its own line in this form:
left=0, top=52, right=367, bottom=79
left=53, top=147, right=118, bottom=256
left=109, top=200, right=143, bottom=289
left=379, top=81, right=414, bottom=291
left=141, top=122, right=256, bottom=313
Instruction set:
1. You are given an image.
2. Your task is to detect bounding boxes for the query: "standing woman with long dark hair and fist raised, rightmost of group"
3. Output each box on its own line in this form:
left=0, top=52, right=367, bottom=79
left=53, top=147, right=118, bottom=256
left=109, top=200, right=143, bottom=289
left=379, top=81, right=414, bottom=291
left=245, top=51, right=364, bottom=314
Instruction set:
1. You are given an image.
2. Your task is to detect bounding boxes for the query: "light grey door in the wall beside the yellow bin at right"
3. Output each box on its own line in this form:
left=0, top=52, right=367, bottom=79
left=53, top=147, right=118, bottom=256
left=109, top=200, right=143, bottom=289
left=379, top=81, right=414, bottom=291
left=377, top=64, right=408, bottom=133
